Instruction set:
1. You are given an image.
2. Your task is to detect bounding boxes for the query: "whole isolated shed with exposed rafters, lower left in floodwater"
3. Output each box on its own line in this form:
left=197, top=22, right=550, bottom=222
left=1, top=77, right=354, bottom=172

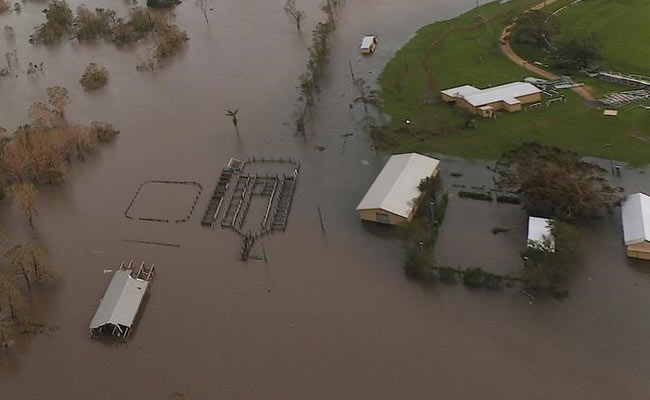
left=89, top=261, right=154, bottom=340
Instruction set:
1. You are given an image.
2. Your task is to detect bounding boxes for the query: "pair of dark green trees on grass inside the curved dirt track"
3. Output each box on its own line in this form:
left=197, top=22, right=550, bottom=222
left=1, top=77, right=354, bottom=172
left=513, top=10, right=602, bottom=71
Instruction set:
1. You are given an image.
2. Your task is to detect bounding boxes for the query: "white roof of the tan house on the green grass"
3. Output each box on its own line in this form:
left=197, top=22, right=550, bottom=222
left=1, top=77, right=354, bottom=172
left=441, top=82, right=541, bottom=107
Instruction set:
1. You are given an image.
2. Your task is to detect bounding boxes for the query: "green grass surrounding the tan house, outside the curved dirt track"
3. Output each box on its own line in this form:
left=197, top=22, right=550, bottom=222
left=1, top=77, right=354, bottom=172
left=374, top=0, right=650, bottom=165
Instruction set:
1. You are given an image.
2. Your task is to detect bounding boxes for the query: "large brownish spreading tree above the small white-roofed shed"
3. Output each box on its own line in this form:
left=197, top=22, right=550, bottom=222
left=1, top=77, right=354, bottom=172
left=496, top=142, right=621, bottom=220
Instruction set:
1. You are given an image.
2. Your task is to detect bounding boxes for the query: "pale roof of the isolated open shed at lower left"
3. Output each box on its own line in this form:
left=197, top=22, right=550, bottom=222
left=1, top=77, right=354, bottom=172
left=90, top=270, right=149, bottom=329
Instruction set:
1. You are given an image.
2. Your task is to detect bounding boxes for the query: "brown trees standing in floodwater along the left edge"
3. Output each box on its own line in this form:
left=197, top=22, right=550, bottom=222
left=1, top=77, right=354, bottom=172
left=0, top=86, right=118, bottom=348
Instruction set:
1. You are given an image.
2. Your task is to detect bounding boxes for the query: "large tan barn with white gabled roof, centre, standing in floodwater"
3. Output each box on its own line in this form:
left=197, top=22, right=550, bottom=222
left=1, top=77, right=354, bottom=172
left=357, top=153, right=440, bottom=225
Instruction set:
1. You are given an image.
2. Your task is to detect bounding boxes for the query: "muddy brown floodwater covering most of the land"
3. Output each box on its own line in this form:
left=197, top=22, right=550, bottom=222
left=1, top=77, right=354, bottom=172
left=0, top=0, right=650, bottom=400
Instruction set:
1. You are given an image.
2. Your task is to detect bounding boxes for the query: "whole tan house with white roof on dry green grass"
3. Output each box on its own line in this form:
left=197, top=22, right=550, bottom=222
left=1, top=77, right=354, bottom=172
left=440, top=82, right=542, bottom=118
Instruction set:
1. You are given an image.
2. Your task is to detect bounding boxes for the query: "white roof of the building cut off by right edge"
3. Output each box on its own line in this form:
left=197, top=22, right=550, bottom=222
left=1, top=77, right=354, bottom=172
left=621, top=193, right=650, bottom=246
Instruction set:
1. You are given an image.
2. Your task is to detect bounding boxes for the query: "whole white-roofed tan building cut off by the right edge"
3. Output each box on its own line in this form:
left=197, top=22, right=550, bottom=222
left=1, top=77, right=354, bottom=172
left=621, top=193, right=650, bottom=260
